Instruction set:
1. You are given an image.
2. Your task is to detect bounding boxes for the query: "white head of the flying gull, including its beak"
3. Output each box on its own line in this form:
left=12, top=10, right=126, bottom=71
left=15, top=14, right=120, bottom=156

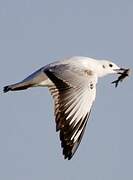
left=88, top=60, right=124, bottom=77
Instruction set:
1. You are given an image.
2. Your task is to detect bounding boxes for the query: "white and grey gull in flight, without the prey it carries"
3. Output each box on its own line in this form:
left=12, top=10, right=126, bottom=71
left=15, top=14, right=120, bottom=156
left=3, top=56, right=128, bottom=160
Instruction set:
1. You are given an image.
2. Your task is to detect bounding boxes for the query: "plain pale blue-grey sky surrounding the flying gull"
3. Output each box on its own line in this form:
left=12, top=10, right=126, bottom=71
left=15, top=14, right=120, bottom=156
left=0, top=0, right=133, bottom=180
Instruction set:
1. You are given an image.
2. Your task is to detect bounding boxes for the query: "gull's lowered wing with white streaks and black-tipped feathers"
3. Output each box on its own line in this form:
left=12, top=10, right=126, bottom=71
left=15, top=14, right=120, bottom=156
left=45, top=65, right=97, bottom=159
